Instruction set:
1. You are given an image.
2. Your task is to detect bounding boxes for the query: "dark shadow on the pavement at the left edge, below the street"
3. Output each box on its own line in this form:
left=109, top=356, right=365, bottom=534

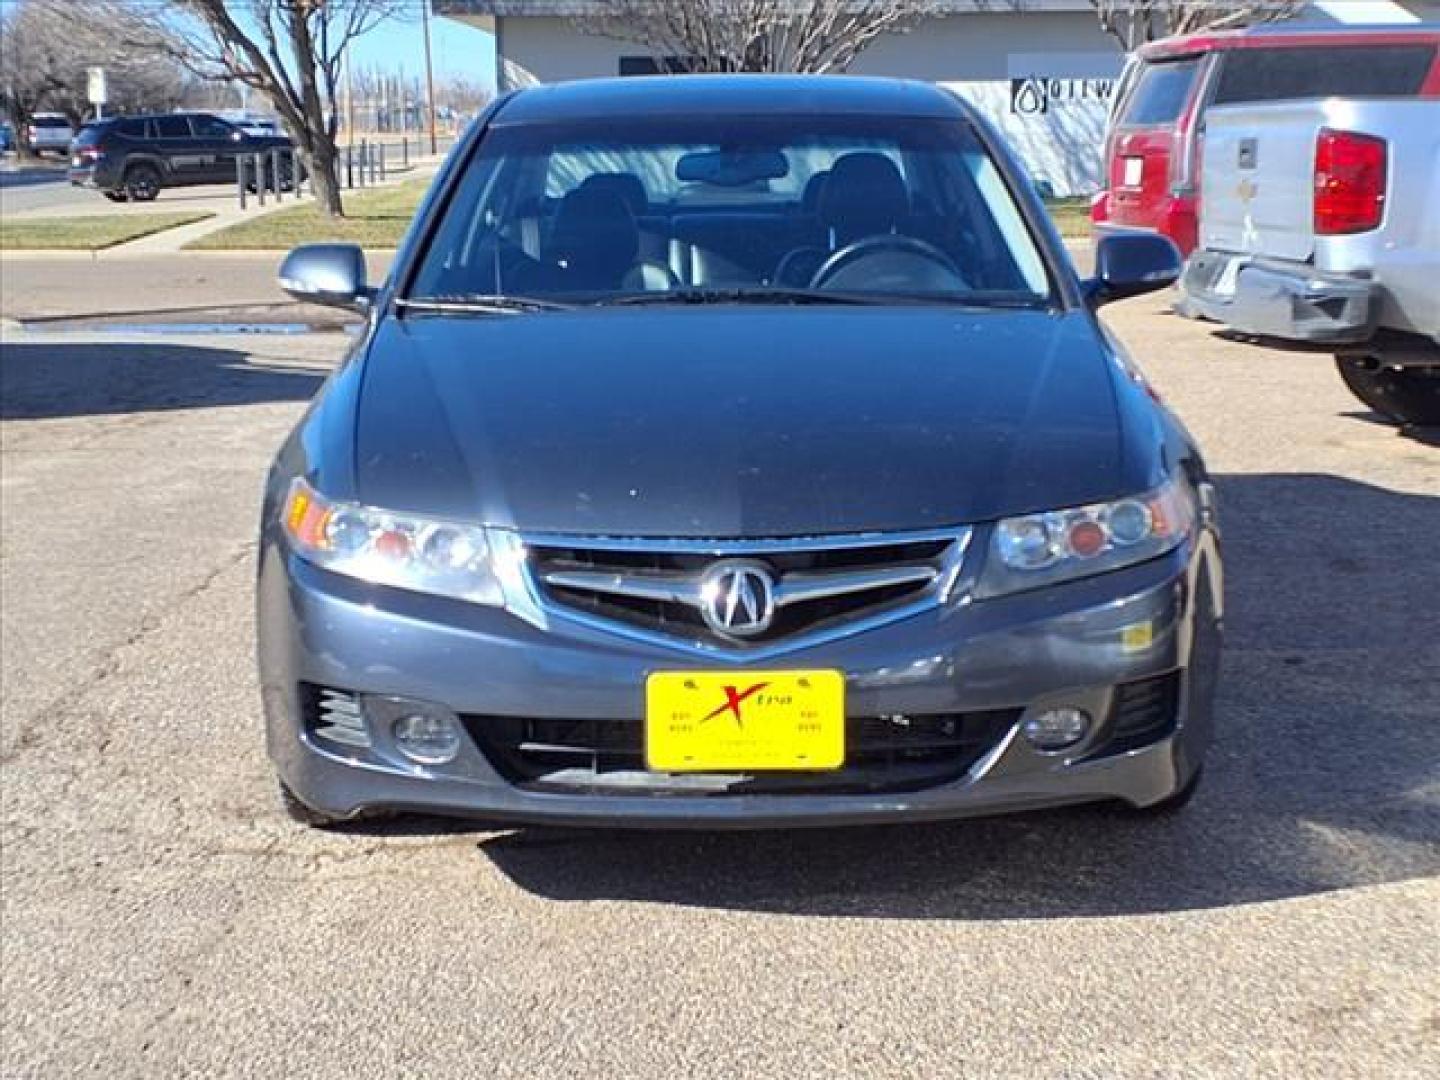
left=0, top=338, right=325, bottom=420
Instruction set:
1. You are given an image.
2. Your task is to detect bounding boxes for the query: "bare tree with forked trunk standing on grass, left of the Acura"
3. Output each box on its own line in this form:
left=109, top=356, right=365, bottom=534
left=85, top=0, right=406, bottom=217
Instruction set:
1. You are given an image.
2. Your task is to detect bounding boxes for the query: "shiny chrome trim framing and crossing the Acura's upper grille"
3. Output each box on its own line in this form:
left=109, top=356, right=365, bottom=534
left=521, top=527, right=973, bottom=662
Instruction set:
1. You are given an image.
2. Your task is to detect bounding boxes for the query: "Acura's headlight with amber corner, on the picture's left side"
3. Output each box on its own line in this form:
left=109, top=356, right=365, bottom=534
left=281, top=477, right=504, bottom=606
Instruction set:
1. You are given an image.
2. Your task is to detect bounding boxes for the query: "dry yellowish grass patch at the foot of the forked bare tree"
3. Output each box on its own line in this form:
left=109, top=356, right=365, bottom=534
left=187, top=180, right=431, bottom=251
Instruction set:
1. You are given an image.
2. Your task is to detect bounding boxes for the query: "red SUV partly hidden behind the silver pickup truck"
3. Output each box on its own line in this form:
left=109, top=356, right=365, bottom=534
left=1090, top=23, right=1440, bottom=255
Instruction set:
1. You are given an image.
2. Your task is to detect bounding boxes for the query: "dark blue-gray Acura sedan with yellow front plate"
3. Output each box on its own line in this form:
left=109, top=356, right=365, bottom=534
left=259, top=76, right=1223, bottom=828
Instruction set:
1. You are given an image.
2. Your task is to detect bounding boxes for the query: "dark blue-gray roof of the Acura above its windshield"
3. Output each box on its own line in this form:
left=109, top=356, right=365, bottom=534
left=494, top=75, right=968, bottom=125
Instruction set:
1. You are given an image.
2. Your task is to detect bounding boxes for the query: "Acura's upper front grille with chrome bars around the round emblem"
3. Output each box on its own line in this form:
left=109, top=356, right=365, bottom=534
left=526, top=531, right=968, bottom=651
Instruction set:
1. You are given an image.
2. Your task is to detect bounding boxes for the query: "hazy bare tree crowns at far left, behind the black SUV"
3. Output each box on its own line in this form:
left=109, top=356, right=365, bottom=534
left=0, top=0, right=189, bottom=150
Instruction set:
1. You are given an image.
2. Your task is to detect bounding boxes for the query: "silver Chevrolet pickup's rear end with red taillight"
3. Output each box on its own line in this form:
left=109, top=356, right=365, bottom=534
left=1181, top=98, right=1440, bottom=425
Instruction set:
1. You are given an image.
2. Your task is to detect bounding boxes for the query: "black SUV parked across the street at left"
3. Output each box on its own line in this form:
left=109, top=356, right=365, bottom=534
left=69, top=112, right=291, bottom=203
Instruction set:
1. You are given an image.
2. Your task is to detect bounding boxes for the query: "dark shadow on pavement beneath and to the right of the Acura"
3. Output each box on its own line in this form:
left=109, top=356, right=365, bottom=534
left=463, top=475, right=1440, bottom=919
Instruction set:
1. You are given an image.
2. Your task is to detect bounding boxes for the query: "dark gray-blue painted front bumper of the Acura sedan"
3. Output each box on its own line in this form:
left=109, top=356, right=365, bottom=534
left=259, top=534, right=1220, bottom=828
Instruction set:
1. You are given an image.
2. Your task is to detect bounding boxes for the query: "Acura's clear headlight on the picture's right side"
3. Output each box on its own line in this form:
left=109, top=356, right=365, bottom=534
left=975, top=480, right=1195, bottom=599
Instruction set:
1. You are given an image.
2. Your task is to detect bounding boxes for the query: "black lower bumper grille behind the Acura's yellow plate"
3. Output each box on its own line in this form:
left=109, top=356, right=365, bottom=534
left=462, top=708, right=1021, bottom=795
